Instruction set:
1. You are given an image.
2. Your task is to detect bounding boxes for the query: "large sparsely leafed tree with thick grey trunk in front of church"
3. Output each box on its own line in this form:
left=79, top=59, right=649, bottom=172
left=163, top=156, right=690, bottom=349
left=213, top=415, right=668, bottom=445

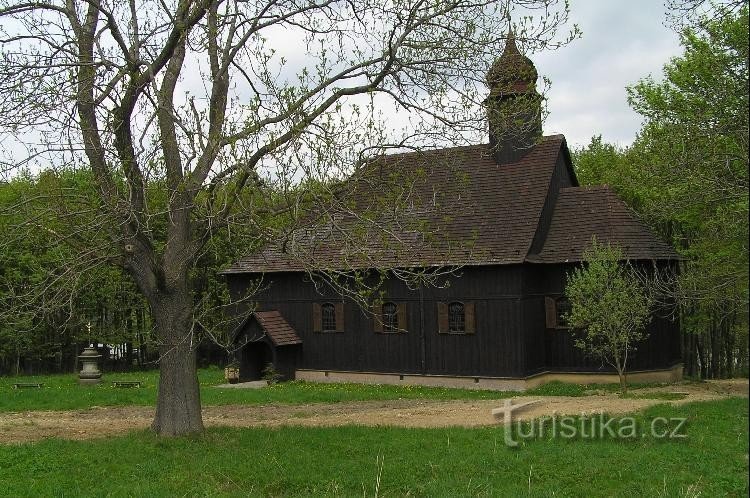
left=0, top=0, right=577, bottom=435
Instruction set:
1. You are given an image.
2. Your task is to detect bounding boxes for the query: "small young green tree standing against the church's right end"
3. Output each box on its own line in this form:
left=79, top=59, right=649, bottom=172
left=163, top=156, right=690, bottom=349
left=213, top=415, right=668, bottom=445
left=565, top=239, right=652, bottom=392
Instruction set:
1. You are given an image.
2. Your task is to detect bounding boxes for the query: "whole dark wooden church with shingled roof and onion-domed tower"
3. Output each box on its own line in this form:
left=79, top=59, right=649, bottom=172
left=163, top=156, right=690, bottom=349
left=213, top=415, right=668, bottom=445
left=223, top=36, right=682, bottom=389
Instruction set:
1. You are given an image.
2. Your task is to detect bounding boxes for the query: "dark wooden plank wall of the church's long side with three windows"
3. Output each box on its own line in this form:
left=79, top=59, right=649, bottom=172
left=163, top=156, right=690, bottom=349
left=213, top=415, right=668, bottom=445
left=229, top=266, right=524, bottom=376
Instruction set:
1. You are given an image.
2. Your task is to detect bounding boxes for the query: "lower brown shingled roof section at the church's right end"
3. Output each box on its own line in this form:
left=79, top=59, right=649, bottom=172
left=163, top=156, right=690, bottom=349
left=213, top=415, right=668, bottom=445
left=527, top=185, right=679, bottom=263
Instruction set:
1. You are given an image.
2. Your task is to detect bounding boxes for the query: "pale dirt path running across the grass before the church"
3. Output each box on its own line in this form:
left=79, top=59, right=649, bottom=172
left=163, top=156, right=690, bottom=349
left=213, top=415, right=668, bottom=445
left=0, top=379, right=748, bottom=444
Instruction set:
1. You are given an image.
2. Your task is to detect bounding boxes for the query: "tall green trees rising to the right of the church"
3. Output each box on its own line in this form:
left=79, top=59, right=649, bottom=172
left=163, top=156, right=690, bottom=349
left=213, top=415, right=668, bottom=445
left=574, top=3, right=749, bottom=378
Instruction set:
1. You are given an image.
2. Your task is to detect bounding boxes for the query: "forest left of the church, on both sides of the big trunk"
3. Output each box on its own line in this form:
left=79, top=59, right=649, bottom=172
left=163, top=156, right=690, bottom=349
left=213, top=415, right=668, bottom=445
left=0, top=169, right=252, bottom=374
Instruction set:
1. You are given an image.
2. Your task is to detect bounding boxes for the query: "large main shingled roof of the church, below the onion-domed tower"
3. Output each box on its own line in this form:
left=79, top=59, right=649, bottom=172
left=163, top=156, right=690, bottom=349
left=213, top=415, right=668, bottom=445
left=223, top=135, right=564, bottom=273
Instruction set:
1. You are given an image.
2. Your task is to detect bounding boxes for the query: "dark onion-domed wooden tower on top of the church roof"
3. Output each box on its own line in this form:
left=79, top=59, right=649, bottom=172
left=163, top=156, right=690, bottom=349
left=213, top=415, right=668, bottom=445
left=484, top=31, right=542, bottom=164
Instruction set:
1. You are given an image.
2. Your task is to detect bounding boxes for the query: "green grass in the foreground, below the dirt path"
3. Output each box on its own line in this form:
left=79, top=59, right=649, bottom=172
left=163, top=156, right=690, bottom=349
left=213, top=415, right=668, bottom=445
left=0, top=398, right=748, bottom=497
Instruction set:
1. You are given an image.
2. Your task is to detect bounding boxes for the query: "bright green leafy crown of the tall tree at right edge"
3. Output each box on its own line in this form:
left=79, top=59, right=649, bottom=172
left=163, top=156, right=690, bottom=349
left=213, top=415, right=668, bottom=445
left=629, top=6, right=750, bottom=365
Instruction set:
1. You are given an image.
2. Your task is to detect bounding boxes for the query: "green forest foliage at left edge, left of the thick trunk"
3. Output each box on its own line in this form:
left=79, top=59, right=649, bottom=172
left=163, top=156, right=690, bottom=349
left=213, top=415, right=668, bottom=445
left=0, top=170, right=153, bottom=368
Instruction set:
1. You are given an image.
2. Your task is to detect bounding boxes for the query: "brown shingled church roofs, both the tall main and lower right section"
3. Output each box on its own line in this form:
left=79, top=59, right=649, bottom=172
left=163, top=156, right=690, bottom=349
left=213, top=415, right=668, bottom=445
left=222, top=135, right=679, bottom=274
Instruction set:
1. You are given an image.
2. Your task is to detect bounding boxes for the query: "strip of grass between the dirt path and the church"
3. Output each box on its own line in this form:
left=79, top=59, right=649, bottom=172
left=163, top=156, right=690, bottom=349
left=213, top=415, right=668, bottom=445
left=0, top=368, right=655, bottom=411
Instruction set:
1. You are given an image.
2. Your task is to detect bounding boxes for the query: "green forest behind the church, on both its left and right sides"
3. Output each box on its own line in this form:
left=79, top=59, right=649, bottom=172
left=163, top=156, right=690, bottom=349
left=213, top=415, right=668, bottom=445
left=0, top=7, right=748, bottom=378
